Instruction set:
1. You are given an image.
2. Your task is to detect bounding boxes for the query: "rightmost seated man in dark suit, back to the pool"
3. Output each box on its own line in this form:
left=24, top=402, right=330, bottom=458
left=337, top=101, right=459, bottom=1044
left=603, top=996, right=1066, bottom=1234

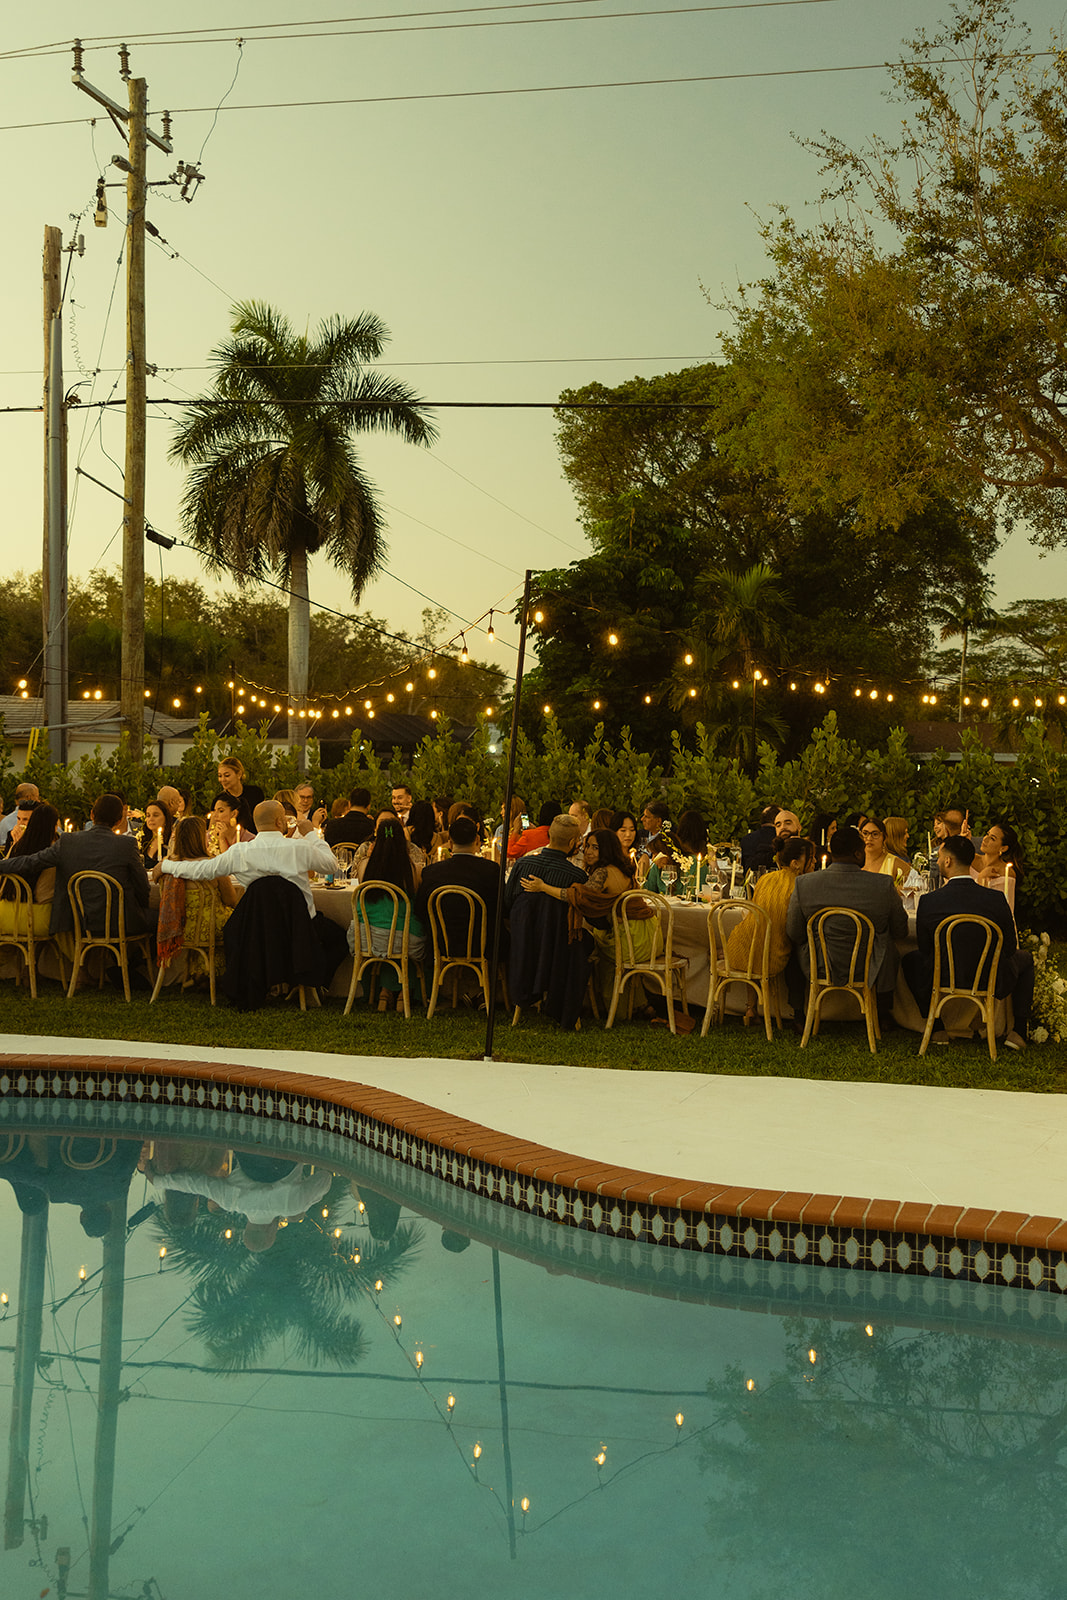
left=904, top=834, right=1033, bottom=1050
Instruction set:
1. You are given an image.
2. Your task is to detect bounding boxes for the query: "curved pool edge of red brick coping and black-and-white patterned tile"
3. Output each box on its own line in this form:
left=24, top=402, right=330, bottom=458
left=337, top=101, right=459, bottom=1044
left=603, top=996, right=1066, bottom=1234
left=0, top=1054, right=1067, bottom=1296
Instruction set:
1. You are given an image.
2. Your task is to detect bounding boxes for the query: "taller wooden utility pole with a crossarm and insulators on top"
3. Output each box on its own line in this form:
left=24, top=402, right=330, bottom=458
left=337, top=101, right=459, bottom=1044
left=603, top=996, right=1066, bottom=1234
left=74, top=40, right=175, bottom=765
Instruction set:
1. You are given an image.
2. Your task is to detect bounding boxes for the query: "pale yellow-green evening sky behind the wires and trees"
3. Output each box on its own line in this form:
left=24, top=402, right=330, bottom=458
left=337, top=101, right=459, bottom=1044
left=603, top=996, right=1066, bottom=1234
left=0, top=0, right=1067, bottom=700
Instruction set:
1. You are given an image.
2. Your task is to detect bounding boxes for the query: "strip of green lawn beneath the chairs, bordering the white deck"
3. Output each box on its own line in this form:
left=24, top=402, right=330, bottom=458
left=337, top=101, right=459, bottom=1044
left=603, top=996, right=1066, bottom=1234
left=0, top=982, right=1067, bottom=1093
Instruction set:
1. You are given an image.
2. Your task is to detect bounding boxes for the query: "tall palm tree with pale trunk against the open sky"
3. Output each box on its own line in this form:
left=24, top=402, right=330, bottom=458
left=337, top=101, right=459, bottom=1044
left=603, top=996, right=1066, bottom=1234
left=170, top=301, right=437, bottom=742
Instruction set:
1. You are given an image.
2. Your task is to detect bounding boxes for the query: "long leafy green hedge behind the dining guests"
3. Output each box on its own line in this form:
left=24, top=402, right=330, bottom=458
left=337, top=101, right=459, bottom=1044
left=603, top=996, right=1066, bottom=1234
left=12, top=712, right=1067, bottom=928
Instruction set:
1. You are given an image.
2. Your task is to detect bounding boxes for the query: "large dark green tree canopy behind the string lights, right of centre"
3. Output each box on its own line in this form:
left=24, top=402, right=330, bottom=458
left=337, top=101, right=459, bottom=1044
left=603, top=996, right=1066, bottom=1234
left=547, top=363, right=995, bottom=747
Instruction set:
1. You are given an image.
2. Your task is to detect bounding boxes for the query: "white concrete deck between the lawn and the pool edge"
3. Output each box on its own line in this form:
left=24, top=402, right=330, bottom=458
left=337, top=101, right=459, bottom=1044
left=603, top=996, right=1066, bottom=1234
left=0, top=1034, right=1067, bottom=1218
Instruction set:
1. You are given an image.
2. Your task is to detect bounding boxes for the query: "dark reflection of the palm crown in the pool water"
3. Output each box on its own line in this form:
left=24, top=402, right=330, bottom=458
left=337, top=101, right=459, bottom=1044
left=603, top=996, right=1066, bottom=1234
left=157, top=1178, right=422, bottom=1373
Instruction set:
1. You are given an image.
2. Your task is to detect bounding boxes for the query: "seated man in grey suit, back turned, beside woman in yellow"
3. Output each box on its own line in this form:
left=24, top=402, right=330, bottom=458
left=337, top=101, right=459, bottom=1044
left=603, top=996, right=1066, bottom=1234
left=785, top=827, right=907, bottom=1029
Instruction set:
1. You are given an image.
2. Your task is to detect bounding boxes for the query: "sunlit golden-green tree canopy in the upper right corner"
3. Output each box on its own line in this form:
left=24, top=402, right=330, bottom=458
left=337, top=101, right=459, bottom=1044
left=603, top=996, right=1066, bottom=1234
left=721, top=0, right=1067, bottom=547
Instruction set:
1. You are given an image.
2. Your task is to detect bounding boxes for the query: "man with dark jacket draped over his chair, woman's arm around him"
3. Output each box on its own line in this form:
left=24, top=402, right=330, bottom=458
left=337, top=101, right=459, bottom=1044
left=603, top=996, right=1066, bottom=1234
left=504, top=814, right=592, bottom=1027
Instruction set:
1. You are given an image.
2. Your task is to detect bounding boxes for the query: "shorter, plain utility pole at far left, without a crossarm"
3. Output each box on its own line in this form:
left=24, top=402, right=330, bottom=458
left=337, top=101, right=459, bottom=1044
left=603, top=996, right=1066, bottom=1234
left=42, top=227, right=68, bottom=766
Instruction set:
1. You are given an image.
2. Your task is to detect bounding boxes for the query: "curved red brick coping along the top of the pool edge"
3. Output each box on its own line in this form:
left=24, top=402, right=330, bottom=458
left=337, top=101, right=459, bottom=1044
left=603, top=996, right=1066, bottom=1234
left=0, top=1054, right=1067, bottom=1251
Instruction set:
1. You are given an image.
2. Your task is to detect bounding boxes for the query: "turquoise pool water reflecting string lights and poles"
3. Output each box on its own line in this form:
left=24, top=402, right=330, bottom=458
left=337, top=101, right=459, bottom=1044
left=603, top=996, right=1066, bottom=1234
left=0, top=1106, right=1067, bottom=1600
